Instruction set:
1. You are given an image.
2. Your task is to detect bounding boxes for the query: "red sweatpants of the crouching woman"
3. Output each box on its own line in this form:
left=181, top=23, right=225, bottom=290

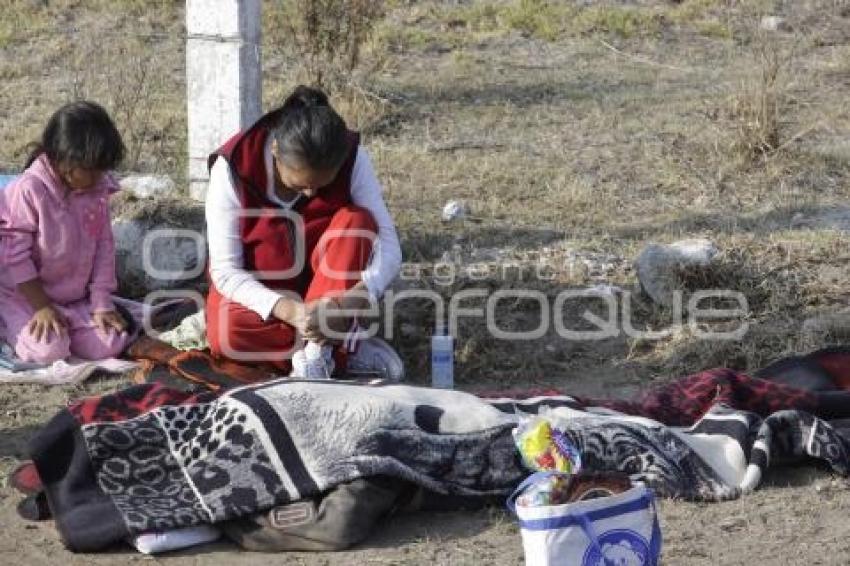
left=206, top=205, right=378, bottom=372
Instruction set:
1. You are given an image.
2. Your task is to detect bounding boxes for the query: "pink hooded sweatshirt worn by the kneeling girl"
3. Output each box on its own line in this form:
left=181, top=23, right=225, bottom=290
left=0, top=154, right=118, bottom=314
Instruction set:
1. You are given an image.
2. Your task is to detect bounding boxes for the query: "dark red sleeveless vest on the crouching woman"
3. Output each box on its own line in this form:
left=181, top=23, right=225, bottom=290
left=212, top=110, right=360, bottom=291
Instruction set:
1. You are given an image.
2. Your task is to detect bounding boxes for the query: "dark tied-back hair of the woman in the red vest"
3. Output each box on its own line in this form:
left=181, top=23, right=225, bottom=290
left=272, top=85, right=348, bottom=171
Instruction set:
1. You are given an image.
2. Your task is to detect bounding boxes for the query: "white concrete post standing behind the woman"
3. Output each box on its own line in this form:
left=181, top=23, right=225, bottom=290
left=186, top=0, right=262, bottom=200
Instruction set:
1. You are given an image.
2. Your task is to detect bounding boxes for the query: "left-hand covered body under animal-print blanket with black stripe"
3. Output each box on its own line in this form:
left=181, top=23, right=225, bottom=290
left=31, top=380, right=524, bottom=551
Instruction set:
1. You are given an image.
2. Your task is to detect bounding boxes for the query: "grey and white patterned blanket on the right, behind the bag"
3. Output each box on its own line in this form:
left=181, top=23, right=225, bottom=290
left=486, top=397, right=850, bottom=501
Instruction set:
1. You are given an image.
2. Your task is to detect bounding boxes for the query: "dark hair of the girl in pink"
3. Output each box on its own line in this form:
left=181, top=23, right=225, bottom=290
left=26, top=100, right=125, bottom=171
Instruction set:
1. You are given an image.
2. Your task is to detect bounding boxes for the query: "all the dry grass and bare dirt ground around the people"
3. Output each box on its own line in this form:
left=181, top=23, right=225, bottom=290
left=0, top=0, right=850, bottom=565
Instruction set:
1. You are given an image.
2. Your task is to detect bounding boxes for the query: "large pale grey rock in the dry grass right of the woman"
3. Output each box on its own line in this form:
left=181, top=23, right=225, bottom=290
left=635, top=240, right=717, bottom=307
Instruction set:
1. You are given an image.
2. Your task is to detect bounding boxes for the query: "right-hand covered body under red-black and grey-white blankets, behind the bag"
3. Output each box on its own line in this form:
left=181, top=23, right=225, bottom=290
left=488, top=364, right=850, bottom=501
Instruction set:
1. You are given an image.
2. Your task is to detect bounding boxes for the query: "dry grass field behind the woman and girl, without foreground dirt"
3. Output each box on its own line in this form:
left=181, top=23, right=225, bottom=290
left=0, top=0, right=850, bottom=389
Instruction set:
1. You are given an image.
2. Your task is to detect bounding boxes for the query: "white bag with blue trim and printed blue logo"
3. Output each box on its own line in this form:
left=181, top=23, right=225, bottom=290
left=508, top=472, right=661, bottom=566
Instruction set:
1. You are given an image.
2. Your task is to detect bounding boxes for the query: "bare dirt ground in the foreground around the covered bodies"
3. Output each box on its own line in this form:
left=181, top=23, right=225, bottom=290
left=0, top=377, right=850, bottom=566
